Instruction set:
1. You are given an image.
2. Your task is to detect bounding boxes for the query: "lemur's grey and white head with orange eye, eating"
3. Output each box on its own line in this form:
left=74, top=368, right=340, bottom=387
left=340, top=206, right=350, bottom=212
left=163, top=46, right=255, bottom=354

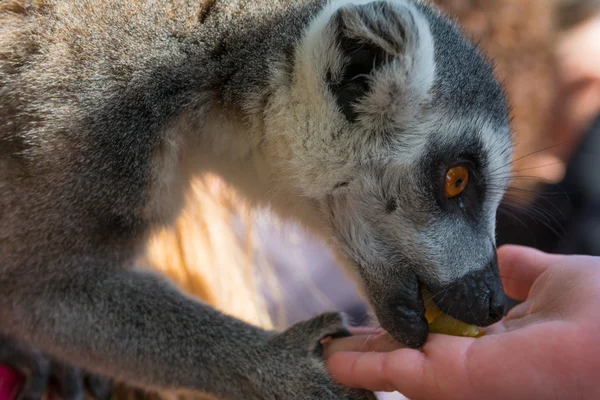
left=269, top=0, right=512, bottom=346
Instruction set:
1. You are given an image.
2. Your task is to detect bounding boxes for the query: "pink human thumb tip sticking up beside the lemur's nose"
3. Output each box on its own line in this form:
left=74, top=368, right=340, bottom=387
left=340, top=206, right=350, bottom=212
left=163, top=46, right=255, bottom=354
left=498, top=245, right=563, bottom=301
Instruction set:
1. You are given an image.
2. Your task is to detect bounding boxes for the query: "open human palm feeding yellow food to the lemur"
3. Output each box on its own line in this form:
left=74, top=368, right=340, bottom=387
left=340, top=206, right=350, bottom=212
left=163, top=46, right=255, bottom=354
left=326, top=246, right=600, bottom=400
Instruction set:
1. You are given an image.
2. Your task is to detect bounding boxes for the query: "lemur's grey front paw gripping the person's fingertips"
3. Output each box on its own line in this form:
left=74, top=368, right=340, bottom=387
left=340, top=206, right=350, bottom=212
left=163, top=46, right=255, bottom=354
left=263, top=313, right=377, bottom=400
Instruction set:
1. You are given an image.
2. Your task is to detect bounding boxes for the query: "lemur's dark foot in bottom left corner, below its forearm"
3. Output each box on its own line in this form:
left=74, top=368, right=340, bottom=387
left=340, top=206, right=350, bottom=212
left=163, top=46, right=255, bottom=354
left=0, top=336, right=113, bottom=400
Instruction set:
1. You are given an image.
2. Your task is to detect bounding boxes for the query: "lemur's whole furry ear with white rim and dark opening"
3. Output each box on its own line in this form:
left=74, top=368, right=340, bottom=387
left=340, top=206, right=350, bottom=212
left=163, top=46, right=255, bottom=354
left=326, top=1, right=434, bottom=122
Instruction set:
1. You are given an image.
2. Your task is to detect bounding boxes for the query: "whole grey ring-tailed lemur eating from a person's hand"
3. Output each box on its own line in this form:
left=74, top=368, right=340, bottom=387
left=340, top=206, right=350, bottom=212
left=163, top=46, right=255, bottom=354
left=0, top=0, right=512, bottom=399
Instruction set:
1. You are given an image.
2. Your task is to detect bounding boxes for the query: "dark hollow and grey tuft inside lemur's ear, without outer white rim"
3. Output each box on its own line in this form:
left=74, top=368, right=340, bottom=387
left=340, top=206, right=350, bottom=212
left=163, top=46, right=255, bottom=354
left=327, top=1, right=426, bottom=121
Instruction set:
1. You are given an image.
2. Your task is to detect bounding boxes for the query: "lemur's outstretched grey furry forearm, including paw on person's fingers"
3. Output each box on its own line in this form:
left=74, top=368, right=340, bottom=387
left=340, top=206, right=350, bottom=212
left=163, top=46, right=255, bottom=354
left=0, top=268, right=370, bottom=399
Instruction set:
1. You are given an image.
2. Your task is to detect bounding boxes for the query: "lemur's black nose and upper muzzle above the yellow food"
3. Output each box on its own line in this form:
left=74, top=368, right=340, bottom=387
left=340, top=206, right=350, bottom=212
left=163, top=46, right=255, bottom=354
left=428, top=257, right=506, bottom=327
